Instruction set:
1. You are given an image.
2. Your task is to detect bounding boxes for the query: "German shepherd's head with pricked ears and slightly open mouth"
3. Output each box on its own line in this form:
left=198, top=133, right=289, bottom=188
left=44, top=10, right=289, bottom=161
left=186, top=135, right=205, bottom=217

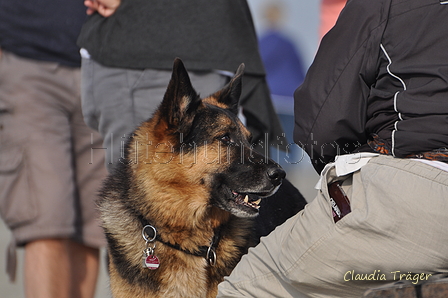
left=131, top=59, right=285, bottom=217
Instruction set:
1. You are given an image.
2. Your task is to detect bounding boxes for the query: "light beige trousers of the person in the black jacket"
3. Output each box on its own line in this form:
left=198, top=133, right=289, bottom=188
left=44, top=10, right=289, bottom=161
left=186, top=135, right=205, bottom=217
left=218, top=156, right=448, bottom=298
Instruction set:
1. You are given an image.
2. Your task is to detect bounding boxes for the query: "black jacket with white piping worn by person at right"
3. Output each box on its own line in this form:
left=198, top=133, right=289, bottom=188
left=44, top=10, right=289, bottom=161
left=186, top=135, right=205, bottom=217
left=294, top=0, right=448, bottom=172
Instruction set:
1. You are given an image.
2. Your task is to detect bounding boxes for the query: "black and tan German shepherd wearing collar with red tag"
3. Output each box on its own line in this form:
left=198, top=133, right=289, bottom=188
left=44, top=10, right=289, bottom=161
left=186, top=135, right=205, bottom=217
left=99, top=59, right=285, bottom=298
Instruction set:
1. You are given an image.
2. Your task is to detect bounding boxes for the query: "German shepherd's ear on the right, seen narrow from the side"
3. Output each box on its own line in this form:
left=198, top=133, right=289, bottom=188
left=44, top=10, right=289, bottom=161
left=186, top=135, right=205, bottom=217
left=214, top=63, right=245, bottom=114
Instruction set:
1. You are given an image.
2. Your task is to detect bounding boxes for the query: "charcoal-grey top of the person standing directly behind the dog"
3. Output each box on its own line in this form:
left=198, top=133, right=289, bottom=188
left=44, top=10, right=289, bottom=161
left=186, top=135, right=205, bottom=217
left=78, top=0, right=264, bottom=75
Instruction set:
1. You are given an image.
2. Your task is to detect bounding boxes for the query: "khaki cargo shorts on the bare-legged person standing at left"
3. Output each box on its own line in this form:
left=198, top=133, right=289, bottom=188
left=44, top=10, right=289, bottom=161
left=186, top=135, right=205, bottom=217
left=0, top=51, right=107, bottom=280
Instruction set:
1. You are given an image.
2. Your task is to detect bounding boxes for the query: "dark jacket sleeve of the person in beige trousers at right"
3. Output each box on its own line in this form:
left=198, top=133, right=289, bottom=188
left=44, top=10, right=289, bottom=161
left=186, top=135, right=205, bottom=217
left=294, top=0, right=391, bottom=173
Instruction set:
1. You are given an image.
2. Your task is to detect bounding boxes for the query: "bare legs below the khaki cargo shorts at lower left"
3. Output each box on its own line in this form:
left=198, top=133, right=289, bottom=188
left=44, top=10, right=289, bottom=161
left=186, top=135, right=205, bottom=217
left=24, top=239, right=99, bottom=298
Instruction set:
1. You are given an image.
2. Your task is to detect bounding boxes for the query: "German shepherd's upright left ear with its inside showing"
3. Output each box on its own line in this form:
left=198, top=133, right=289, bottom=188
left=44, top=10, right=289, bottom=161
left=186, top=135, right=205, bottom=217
left=161, top=58, right=201, bottom=132
